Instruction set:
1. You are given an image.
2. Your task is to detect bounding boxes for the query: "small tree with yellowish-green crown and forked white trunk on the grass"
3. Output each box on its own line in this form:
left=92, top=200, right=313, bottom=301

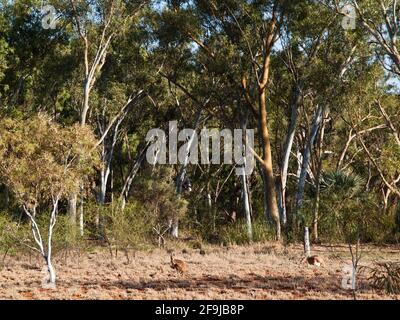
left=0, top=115, right=97, bottom=286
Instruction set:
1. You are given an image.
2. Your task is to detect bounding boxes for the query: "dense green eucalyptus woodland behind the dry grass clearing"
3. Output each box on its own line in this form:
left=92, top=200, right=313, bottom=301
left=0, top=0, right=400, bottom=282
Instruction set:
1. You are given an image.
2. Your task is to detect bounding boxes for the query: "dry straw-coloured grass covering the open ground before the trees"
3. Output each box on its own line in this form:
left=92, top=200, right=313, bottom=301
left=0, top=244, right=400, bottom=299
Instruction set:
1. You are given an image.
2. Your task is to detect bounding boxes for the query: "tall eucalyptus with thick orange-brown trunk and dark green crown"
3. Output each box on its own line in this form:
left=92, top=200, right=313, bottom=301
left=153, top=1, right=289, bottom=238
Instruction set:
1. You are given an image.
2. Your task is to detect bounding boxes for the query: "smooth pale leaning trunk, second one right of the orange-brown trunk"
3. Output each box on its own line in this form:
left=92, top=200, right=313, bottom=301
left=293, top=105, right=324, bottom=224
